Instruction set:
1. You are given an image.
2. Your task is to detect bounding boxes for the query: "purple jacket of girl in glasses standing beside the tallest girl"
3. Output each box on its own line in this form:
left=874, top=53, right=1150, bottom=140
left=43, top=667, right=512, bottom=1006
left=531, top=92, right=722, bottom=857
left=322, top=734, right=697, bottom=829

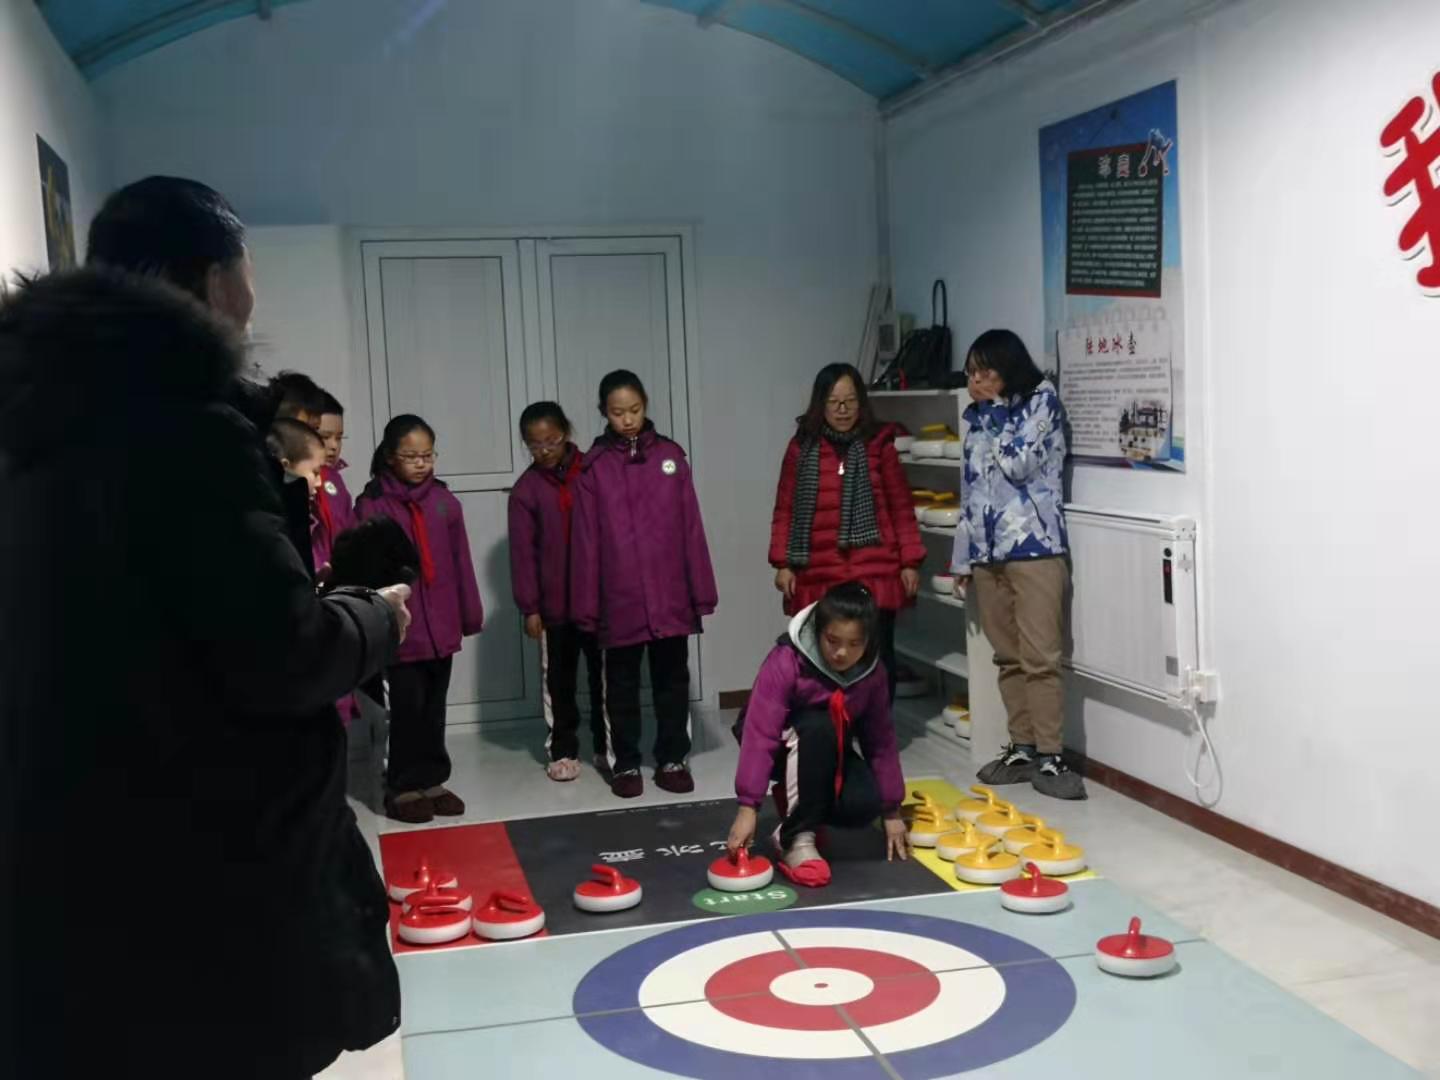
left=510, top=445, right=582, bottom=626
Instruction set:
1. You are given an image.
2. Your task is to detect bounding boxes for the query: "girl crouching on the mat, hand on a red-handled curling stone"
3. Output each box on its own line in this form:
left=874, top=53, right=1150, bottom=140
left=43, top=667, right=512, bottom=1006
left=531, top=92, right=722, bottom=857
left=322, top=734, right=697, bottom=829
left=727, top=582, right=910, bottom=887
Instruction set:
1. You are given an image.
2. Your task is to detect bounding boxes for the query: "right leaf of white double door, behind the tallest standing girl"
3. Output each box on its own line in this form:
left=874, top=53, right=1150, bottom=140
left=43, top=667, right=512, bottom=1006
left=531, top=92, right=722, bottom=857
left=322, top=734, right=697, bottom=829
left=534, top=236, right=702, bottom=701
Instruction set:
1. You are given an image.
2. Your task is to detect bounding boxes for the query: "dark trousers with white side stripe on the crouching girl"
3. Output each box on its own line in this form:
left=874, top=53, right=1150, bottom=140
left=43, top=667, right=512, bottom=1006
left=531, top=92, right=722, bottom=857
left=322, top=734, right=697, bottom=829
left=773, top=708, right=880, bottom=848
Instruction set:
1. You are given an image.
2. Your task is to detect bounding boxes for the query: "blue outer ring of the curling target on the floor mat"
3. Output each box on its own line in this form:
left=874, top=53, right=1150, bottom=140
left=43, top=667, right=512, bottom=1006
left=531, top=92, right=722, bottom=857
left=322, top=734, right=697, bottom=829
left=573, top=910, right=1076, bottom=1080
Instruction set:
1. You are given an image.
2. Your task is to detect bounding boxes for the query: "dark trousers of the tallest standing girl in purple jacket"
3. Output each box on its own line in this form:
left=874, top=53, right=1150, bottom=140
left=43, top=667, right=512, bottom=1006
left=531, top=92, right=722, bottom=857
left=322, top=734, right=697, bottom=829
left=605, top=638, right=690, bottom=772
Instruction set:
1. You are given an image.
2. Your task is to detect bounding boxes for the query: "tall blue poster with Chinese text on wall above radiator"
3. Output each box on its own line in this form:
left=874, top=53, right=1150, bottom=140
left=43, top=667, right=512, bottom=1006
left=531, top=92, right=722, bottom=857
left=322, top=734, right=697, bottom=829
left=1040, top=81, right=1185, bottom=471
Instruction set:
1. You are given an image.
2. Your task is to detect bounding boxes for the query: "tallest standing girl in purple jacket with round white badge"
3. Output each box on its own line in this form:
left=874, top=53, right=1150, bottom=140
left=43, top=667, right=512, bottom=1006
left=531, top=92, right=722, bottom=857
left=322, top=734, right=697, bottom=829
left=570, top=372, right=717, bottom=799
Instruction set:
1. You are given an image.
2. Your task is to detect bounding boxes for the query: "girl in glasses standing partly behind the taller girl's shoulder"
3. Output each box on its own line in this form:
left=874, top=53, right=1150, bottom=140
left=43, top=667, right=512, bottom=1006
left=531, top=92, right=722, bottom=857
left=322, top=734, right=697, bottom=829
left=510, top=402, right=609, bottom=782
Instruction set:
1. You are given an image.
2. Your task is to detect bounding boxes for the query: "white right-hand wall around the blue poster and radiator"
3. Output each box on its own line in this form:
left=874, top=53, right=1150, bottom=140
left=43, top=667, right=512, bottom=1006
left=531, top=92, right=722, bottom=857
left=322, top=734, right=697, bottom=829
left=886, top=0, right=1440, bottom=901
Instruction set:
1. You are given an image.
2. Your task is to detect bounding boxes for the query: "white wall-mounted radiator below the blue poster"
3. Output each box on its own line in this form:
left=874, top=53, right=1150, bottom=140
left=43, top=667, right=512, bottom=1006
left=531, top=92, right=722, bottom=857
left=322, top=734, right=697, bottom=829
left=1066, top=505, right=1200, bottom=704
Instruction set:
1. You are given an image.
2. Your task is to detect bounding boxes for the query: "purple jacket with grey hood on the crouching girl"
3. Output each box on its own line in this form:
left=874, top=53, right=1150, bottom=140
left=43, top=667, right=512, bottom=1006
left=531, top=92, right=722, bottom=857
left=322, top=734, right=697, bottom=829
left=734, top=605, right=904, bottom=811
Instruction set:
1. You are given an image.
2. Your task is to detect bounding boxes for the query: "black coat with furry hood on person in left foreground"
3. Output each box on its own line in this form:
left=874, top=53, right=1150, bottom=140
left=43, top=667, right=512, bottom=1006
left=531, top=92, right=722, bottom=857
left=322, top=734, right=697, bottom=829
left=0, top=269, right=409, bottom=1080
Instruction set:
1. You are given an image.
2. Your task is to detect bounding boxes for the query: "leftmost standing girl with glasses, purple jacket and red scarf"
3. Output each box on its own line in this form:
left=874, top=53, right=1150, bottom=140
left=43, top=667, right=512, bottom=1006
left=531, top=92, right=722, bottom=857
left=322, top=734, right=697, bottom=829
left=356, top=415, right=484, bottom=824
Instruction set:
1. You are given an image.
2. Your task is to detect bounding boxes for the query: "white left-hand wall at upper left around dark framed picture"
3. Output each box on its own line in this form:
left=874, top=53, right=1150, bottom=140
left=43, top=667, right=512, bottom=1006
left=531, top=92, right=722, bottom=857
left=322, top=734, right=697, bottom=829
left=0, top=0, right=105, bottom=278
